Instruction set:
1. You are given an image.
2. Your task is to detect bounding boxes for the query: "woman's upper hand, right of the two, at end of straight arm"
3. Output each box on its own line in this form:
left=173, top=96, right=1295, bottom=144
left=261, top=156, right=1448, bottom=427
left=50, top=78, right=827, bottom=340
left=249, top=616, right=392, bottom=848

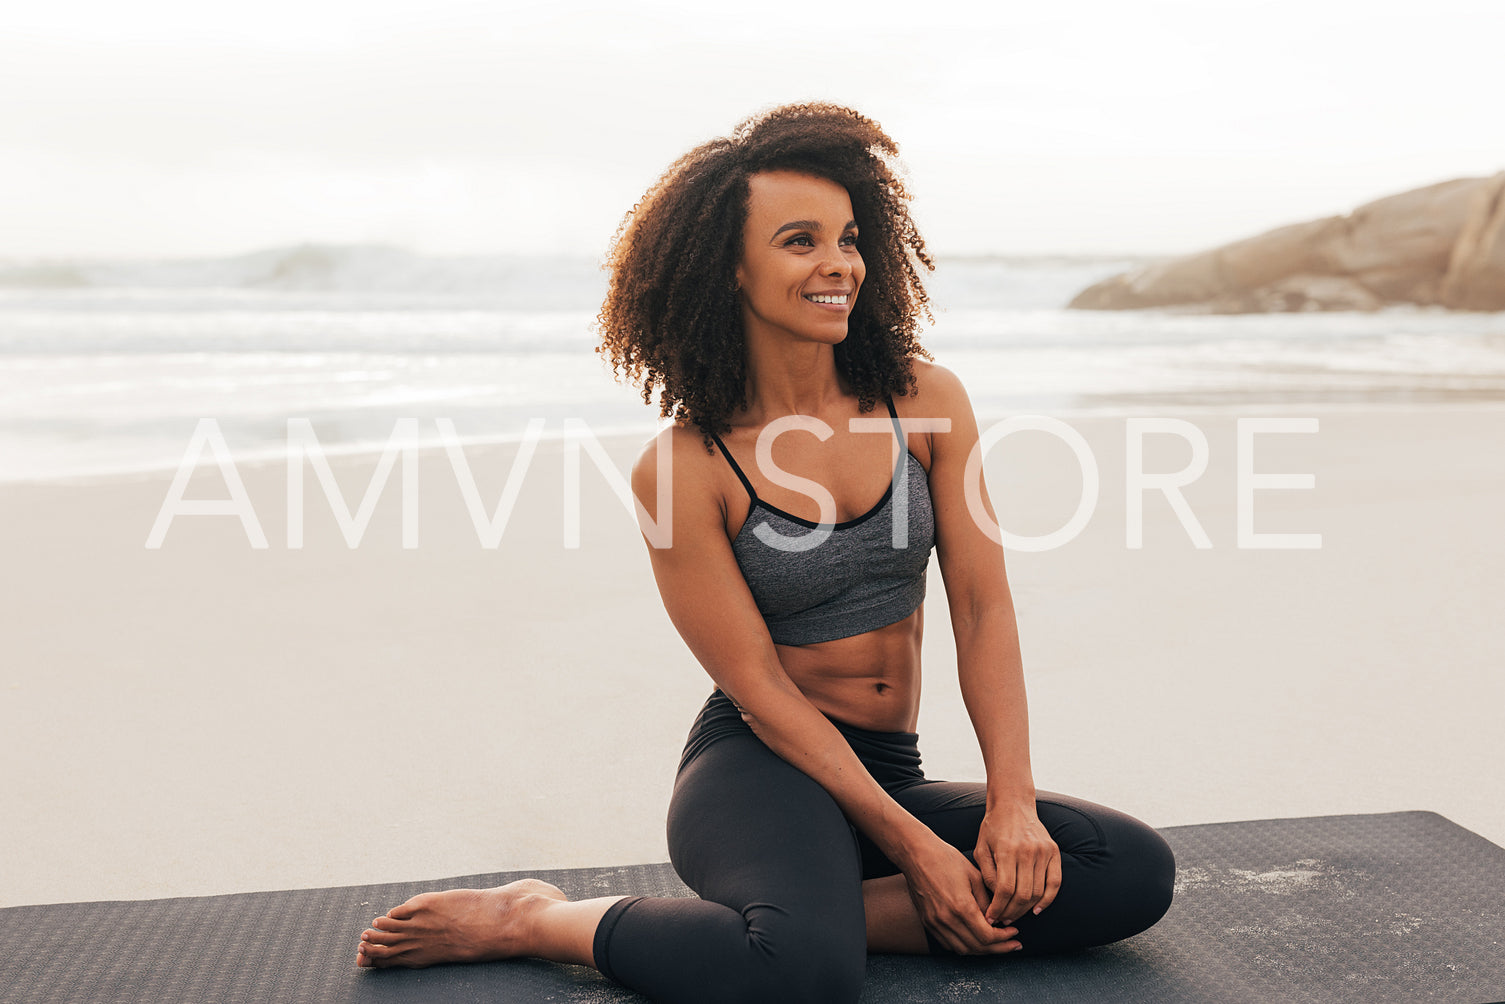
left=972, top=799, right=1061, bottom=924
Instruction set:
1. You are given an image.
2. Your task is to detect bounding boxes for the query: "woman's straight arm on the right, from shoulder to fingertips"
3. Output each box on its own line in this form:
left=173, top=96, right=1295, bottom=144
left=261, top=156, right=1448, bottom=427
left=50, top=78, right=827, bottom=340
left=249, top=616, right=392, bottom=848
left=912, top=366, right=1061, bottom=923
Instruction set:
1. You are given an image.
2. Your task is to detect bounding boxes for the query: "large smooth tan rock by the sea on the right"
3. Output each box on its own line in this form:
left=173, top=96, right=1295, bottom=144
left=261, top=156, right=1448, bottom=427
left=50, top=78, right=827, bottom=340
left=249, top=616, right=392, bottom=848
left=1070, top=172, right=1505, bottom=313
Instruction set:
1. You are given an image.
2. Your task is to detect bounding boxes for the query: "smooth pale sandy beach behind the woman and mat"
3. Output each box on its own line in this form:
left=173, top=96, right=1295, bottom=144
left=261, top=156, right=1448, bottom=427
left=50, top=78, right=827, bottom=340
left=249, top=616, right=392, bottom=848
left=0, top=405, right=1505, bottom=906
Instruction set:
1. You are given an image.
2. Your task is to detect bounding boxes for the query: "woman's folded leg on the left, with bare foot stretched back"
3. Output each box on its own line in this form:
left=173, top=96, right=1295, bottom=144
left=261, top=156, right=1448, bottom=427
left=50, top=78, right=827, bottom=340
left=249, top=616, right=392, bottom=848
left=357, top=733, right=903, bottom=1002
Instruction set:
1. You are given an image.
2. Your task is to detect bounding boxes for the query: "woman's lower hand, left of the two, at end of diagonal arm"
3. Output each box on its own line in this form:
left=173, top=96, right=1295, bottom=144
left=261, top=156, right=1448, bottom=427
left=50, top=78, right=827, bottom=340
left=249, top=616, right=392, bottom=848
left=905, top=837, right=1019, bottom=956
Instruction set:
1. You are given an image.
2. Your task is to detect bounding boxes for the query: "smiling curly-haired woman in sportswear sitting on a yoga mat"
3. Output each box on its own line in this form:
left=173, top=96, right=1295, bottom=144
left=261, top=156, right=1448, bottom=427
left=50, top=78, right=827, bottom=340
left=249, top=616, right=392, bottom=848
left=358, top=105, right=1174, bottom=1004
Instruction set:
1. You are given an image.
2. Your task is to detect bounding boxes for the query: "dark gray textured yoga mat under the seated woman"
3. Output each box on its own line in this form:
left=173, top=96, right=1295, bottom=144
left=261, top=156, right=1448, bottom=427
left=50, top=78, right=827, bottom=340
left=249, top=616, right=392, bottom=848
left=0, top=813, right=1505, bottom=1004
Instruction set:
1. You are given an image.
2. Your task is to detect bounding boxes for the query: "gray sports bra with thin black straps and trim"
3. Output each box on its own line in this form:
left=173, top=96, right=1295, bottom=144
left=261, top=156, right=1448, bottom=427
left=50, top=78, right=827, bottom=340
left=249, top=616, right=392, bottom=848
left=710, top=400, right=935, bottom=644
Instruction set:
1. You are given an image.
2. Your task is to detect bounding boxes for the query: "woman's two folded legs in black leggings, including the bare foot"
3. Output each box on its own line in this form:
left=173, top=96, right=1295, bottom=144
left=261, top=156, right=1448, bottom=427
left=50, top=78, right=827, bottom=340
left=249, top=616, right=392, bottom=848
left=357, top=733, right=1174, bottom=1001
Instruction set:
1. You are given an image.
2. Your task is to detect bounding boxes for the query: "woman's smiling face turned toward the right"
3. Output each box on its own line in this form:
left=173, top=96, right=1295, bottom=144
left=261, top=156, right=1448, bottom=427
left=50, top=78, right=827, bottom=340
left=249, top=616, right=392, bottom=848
left=736, top=170, right=867, bottom=345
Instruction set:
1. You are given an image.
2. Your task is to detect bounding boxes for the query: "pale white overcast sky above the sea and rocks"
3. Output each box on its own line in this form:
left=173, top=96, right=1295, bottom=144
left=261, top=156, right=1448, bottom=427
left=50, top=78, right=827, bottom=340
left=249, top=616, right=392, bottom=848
left=0, top=0, right=1505, bottom=259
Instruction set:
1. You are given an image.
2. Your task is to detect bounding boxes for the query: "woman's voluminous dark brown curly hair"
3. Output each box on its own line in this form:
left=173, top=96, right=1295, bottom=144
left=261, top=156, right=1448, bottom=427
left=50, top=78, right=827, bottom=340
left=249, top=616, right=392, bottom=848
left=596, top=104, right=935, bottom=447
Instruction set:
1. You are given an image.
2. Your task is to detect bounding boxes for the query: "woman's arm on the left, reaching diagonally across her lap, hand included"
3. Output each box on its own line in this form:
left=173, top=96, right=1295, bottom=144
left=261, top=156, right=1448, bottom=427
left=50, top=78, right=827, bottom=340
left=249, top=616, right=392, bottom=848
left=632, top=427, right=1010, bottom=954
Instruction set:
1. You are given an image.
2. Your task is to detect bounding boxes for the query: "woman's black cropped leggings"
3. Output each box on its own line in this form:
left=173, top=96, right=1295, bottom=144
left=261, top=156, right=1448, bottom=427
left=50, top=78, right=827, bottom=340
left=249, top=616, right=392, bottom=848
left=594, top=691, right=1175, bottom=1004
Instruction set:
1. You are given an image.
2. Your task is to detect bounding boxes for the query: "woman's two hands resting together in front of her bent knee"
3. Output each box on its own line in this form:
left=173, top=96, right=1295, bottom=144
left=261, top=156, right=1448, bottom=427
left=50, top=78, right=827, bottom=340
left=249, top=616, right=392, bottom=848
left=905, top=805, right=1061, bottom=954
